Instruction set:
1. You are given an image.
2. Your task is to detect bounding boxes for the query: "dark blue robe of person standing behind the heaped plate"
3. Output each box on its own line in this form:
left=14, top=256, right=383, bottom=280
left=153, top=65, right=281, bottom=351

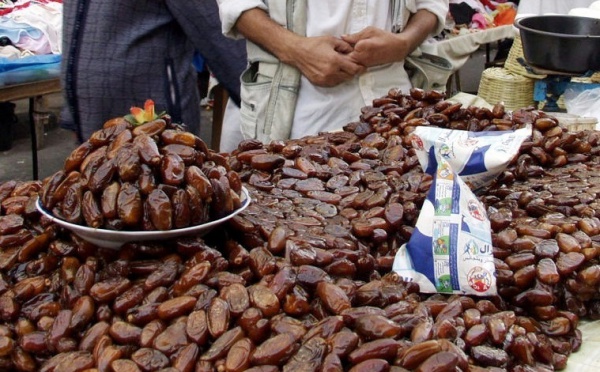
left=61, top=0, right=246, bottom=141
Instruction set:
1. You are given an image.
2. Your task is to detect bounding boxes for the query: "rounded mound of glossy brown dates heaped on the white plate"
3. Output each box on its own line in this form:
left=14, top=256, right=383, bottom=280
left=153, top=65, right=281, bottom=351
left=40, top=115, right=242, bottom=231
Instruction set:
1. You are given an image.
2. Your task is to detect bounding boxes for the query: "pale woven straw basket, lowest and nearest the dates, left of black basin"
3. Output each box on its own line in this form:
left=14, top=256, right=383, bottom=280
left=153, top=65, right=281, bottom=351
left=477, top=67, right=535, bottom=111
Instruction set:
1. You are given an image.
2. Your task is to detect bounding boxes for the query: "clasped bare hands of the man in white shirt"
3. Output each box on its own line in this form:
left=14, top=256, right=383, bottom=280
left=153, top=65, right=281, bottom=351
left=293, top=27, right=408, bottom=87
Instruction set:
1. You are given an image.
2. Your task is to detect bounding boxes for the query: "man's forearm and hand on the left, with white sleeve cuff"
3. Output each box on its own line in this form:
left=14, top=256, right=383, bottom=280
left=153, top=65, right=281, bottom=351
left=219, top=0, right=364, bottom=86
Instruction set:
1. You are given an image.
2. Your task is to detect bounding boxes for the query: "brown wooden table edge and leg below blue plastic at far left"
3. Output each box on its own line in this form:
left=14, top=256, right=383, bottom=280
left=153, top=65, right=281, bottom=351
left=0, top=78, right=60, bottom=180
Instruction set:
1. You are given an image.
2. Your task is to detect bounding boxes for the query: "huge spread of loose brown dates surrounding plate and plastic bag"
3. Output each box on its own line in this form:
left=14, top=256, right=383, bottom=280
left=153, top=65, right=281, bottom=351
left=0, top=89, right=600, bottom=372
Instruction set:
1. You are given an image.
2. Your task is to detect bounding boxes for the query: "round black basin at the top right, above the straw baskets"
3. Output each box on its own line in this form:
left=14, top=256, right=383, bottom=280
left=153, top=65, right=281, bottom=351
left=515, top=15, right=600, bottom=75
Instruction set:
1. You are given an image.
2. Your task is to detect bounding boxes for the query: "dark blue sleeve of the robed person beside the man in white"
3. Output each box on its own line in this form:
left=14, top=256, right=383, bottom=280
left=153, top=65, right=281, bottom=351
left=167, top=0, right=247, bottom=106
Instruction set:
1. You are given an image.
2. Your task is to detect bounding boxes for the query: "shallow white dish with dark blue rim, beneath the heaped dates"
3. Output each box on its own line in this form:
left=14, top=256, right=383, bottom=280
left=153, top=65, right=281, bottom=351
left=36, top=187, right=251, bottom=249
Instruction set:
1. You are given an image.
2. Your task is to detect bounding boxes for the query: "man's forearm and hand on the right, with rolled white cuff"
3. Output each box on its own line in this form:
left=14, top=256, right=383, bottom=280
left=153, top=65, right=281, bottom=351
left=342, top=0, right=448, bottom=67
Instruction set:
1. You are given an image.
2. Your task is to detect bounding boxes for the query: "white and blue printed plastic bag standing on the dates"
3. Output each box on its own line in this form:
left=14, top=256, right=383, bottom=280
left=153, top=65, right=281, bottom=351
left=394, top=126, right=531, bottom=296
